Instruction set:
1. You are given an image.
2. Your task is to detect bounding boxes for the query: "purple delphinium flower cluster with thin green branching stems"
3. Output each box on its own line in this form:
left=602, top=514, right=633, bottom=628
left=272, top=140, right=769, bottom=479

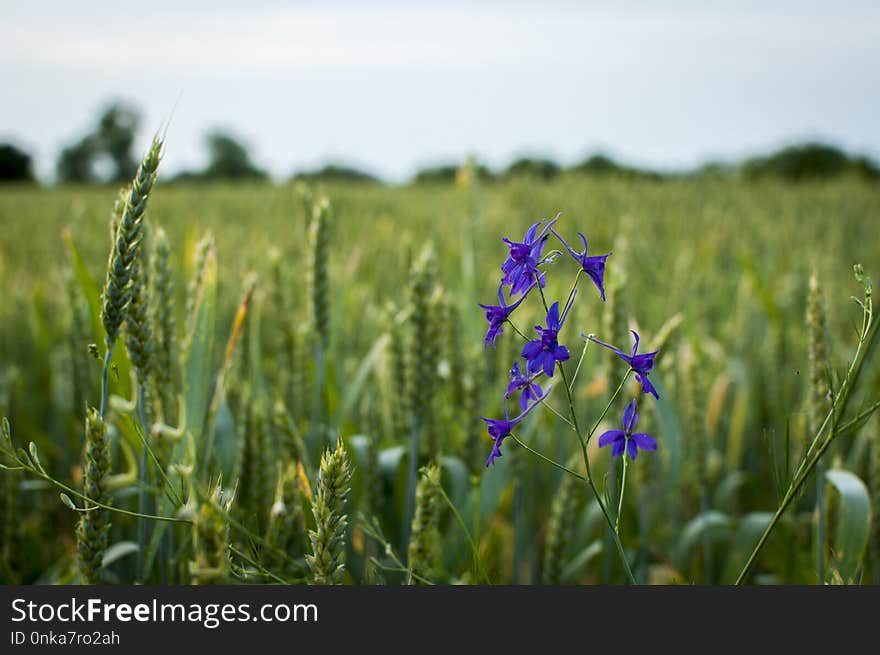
left=480, top=216, right=659, bottom=582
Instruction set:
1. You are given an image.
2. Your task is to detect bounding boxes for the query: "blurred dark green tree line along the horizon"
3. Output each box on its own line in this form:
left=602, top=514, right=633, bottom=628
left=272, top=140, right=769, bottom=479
left=0, top=102, right=880, bottom=184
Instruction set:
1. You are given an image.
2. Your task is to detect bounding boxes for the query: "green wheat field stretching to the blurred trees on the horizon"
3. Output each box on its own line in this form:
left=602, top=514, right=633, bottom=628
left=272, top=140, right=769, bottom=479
left=0, top=143, right=880, bottom=584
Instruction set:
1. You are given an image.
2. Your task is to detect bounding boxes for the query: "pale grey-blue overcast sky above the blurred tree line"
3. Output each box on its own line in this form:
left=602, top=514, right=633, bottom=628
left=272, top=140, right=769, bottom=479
left=0, top=0, right=880, bottom=180
